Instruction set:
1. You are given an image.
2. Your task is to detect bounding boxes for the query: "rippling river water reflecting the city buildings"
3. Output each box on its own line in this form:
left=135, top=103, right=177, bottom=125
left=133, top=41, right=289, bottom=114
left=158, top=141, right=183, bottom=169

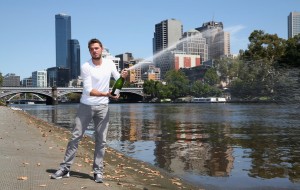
left=13, top=103, right=300, bottom=189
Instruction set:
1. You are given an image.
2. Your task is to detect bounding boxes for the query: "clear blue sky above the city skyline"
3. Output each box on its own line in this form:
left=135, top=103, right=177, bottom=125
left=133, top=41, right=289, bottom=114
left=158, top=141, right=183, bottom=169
left=0, top=0, right=300, bottom=79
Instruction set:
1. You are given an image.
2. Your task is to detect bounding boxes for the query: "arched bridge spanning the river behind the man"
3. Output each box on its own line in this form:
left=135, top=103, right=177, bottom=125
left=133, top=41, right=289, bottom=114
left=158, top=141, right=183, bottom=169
left=0, top=87, right=144, bottom=105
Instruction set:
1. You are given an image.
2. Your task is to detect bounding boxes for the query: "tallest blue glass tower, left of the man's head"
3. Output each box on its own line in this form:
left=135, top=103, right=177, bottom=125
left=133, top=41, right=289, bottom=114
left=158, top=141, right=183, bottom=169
left=55, top=14, right=71, bottom=68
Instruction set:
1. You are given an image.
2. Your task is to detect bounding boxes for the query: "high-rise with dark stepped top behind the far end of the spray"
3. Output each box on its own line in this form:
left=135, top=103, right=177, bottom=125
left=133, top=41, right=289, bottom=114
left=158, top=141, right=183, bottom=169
left=196, top=21, right=231, bottom=60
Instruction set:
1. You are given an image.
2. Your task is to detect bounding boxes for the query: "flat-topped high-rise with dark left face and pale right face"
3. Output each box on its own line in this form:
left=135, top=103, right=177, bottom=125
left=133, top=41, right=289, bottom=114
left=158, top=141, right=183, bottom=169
left=153, top=19, right=183, bottom=54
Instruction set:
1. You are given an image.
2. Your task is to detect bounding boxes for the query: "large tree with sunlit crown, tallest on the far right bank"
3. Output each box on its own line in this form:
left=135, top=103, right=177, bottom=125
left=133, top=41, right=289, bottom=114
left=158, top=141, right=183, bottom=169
left=230, top=30, right=286, bottom=99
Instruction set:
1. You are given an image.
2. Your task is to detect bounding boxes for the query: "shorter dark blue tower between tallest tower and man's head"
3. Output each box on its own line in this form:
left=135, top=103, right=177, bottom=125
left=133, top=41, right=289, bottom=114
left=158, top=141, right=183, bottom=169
left=69, top=39, right=80, bottom=79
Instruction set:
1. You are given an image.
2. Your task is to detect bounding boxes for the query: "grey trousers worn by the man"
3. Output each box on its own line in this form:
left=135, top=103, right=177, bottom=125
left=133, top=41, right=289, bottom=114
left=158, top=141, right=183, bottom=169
left=60, top=103, right=109, bottom=175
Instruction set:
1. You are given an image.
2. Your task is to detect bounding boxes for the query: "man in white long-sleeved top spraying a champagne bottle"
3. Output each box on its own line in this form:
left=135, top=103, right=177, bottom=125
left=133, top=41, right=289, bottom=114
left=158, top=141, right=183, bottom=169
left=51, top=39, right=128, bottom=183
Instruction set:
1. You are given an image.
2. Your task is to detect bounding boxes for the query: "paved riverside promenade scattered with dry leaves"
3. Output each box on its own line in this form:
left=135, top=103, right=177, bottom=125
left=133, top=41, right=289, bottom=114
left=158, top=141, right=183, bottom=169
left=0, top=106, right=200, bottom=190
